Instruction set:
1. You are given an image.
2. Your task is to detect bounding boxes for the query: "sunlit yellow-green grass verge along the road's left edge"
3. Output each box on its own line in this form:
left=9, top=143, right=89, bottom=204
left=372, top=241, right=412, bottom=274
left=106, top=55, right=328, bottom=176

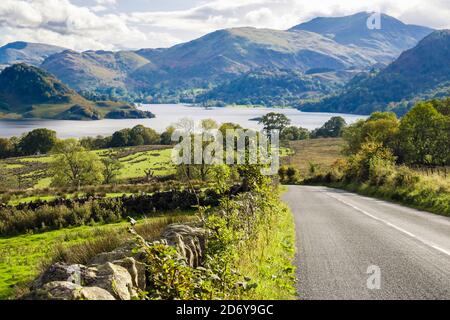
left=238, top=199, right=297, bottom=300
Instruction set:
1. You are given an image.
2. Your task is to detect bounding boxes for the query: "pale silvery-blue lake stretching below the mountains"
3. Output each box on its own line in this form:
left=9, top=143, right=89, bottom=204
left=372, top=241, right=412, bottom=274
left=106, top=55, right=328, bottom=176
left=0, top=104, right=367, bottom=138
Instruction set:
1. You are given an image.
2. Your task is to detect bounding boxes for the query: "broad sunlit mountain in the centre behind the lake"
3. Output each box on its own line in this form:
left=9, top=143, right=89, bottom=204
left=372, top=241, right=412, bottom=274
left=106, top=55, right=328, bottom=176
left=130, top=28, right=377, bottom=96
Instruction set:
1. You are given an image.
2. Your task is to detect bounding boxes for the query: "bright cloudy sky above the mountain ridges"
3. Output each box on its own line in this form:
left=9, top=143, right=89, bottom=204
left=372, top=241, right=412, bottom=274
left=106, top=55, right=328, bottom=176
left=0, top=0, right=450, bottom=51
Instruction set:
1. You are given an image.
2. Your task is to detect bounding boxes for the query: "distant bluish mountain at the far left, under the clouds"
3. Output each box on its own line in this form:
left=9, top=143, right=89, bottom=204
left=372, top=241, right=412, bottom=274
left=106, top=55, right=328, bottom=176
left=0, top=41, right=66, bottom=66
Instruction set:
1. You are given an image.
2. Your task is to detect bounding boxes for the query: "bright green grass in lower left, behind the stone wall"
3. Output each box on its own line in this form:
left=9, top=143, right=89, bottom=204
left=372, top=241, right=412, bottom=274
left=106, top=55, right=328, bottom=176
left=0, top=212, right=192, bottom=299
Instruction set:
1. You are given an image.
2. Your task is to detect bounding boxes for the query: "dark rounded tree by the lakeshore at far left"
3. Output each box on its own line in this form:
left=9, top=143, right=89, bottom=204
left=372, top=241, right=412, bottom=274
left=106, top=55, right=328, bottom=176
left=19, top=129, right=57, bottom=155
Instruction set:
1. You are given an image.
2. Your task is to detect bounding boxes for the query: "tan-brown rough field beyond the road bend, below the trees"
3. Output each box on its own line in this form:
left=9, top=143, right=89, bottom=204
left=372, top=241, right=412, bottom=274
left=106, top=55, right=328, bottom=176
left=282, top=138, right=345, bottom=176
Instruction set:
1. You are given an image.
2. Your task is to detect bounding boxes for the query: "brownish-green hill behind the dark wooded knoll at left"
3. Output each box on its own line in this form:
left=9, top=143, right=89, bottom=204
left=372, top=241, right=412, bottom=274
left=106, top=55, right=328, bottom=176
left=41, top=50, right=151, bottom=90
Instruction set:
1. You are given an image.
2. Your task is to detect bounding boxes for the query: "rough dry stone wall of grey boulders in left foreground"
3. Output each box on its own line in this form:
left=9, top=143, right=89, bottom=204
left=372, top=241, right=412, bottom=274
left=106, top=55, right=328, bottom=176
left=24, top=224, right=206, bottom=300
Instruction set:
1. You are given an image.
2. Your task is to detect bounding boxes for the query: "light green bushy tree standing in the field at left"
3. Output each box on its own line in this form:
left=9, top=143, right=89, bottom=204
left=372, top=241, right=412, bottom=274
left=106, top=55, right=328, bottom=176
left=51, top=139, right=104, bottom=188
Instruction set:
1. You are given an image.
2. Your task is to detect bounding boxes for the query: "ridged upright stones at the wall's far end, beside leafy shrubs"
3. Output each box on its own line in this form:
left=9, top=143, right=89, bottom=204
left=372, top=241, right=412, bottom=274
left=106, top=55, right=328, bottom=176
left=162, top=224, right=206, bottom=268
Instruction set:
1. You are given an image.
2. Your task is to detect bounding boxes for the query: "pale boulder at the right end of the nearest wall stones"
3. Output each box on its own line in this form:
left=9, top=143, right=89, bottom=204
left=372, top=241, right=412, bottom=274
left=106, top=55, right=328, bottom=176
left=93, top=262, right=135, bottom=300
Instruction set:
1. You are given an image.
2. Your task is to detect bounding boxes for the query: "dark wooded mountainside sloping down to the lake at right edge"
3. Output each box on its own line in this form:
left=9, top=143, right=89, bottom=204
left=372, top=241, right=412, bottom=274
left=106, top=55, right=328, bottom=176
left=300, top=30, right=450, bottom=115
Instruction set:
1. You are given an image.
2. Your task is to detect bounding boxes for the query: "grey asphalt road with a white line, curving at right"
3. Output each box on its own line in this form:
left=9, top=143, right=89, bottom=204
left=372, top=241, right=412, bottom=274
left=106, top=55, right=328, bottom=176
left=283, top=186, right=450, bottom=300
